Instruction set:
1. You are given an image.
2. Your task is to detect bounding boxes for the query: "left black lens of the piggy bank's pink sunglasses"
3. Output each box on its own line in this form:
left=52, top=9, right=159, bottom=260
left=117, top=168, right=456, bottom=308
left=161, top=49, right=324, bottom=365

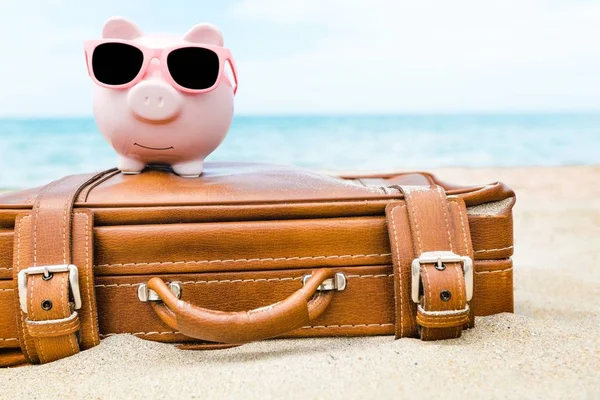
left=92, top=43, right=144, bottom=86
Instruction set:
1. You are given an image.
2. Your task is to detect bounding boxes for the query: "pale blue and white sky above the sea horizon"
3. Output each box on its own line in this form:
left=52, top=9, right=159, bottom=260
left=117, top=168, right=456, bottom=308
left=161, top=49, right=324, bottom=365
left=0, top=0, right=600, bottom=117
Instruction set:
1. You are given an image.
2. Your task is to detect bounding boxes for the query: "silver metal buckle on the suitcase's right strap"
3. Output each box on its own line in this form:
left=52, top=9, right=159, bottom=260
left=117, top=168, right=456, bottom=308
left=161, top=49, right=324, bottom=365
left=411, top=251, right=473, bottom=303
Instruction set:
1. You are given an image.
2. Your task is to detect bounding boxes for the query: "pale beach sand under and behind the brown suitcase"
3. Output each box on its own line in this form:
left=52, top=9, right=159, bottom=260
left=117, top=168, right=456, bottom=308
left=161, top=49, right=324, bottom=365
left=0, top=166, right=600, bottom=400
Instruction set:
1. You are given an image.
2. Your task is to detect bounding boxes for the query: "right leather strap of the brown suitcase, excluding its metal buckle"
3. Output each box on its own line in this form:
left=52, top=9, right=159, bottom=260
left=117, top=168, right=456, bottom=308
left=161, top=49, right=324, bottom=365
left=386, top=185, right=473, bottom=340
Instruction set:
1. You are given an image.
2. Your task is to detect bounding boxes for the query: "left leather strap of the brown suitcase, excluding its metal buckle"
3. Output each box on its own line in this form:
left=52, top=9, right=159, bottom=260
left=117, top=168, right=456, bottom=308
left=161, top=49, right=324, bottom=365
left=13, top=170, right=113, bottom=363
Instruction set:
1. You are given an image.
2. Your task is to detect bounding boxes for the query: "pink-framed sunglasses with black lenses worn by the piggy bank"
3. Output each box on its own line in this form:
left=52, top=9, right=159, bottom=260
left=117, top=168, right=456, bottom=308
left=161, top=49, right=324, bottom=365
left=85, top=39, right=238, bottom=94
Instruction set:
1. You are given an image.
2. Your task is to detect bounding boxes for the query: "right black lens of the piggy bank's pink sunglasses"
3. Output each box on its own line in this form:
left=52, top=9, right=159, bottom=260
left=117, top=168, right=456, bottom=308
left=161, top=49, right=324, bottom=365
left=167, top=47, right=219, bottom=90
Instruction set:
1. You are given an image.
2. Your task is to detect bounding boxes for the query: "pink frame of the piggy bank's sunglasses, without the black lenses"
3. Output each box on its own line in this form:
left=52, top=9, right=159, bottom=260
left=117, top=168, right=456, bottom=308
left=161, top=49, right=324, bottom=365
left=84, top=39, right=238, bottom=95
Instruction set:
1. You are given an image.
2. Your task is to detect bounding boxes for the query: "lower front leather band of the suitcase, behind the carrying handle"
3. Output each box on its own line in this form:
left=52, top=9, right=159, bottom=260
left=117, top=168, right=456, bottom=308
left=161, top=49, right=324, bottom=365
left=0, top=260, right=513, bottom=348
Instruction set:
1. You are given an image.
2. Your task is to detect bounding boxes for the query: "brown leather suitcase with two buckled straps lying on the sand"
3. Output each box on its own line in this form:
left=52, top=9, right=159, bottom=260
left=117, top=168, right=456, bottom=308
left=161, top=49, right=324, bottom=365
left=0, top=163, right=515, bottom=366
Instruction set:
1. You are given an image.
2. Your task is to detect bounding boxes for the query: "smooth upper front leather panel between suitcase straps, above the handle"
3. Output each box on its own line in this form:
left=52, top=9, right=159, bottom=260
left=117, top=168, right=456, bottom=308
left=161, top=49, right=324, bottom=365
left=95, top=217, right=391, bottom=275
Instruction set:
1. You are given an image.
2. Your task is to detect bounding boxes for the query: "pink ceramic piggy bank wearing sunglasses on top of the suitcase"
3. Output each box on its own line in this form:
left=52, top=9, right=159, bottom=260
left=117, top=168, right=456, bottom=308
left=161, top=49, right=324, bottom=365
left=85, top=17, right=237, bottom=177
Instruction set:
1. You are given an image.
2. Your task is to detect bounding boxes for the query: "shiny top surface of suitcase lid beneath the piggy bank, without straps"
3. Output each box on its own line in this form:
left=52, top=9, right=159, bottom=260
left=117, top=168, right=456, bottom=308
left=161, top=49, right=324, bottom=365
left=0, top=163, right=514, bottom=208
